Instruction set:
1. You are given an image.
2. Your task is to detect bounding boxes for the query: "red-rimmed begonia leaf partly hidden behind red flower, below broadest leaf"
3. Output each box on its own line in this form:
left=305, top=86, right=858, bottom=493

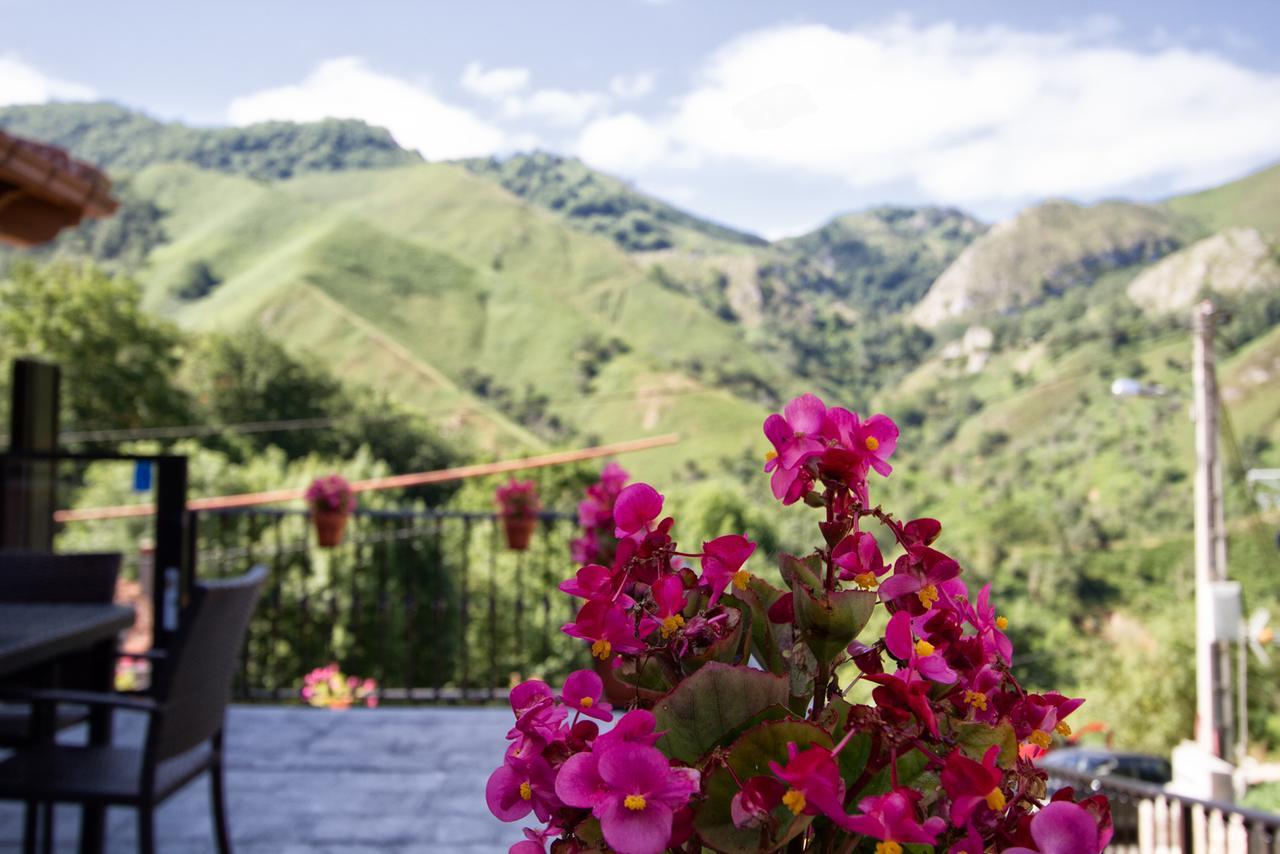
left=694, top=718, right=832, bottom=854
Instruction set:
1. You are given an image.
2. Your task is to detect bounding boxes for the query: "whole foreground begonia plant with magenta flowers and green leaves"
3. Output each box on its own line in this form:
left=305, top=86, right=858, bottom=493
left=489, top=394, right=1111, bottom=854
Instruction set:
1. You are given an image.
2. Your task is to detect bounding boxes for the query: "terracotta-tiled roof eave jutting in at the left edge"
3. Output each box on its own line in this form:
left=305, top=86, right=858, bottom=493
left=0, top=131, right=119, bottom=246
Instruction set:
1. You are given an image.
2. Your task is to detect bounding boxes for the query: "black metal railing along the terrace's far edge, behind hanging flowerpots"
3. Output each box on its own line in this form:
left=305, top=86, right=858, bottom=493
left=196, top=508, right=585, bottom=703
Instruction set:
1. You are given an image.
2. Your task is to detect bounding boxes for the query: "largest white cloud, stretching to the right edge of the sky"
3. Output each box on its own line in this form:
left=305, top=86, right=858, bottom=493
left=579, top=19, right=1280, bottom=206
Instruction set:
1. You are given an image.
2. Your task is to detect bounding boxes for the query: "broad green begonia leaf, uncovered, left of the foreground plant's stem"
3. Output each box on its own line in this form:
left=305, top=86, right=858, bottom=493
left=653, top=662, right=787, bottom=764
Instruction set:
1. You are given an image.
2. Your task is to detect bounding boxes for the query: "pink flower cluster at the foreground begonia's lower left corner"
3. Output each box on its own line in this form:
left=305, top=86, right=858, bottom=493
left=485, top=670, right=700, bottom=854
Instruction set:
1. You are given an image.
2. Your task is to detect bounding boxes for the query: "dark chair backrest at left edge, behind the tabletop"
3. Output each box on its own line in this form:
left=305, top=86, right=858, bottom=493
left=0, top=549, right=120, bottom=604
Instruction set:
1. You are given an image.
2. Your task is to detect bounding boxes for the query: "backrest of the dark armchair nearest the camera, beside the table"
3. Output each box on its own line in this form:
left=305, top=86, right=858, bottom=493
left=147, top=566, right=266, bottom=761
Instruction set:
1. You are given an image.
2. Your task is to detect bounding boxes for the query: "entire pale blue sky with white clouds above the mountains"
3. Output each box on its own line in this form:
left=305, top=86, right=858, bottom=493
left=0, top=0, right=1280, bottom=236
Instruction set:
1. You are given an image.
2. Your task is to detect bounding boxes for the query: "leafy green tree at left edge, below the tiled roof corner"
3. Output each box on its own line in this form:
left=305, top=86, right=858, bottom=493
left=0, top=262, right=191, bottom=430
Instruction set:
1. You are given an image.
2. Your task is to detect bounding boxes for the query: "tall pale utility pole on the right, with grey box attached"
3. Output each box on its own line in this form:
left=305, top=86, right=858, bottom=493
left=1192, top=300, right=1231, bottom=789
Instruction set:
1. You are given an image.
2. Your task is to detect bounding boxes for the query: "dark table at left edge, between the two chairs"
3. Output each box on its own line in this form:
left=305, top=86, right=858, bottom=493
left=0, top=602, right=133, bottom=854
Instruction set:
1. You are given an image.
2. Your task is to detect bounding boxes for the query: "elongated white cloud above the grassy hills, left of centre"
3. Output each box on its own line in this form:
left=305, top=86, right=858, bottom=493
left=228, top=56, right=509, bottom=160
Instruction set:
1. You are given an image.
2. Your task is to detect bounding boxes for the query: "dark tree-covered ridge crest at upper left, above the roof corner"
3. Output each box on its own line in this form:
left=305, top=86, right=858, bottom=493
left=0, top=104, right=421, bottom=179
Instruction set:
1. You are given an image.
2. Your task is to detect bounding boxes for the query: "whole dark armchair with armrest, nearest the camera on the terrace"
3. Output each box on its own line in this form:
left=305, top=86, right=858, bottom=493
left=0, top=567, right=266, bottom=854
